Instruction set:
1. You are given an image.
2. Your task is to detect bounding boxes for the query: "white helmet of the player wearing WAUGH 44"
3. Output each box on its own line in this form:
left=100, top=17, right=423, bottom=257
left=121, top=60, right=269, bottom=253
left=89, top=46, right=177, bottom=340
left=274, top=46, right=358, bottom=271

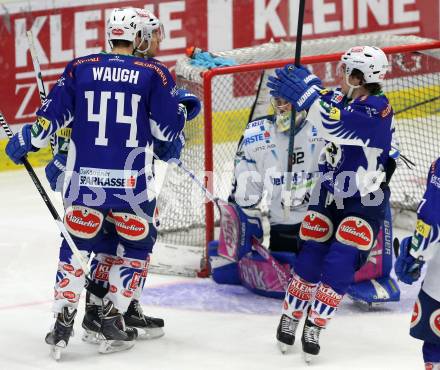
left=107, top=8, right=140, bottom=47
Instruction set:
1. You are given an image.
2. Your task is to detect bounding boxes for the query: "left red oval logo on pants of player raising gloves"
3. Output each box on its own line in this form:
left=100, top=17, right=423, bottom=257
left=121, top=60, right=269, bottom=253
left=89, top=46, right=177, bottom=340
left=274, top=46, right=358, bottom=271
left=299, top=210, right=333, bottom=243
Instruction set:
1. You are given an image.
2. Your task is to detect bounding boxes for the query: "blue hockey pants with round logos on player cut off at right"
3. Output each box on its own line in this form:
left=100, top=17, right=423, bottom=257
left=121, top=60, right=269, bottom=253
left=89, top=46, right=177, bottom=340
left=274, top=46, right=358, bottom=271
left=409, top=289, right=440, bottom=345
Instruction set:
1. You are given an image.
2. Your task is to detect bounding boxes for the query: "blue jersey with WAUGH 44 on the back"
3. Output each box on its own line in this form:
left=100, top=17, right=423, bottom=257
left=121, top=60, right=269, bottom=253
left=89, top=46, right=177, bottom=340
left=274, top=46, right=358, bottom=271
left=28, top=54, right=185, bottom=207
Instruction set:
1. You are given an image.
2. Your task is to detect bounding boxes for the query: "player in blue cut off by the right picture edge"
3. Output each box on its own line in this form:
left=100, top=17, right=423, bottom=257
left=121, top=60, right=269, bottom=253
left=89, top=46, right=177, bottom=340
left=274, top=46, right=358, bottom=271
left=394, top=158, right=440, bottom=370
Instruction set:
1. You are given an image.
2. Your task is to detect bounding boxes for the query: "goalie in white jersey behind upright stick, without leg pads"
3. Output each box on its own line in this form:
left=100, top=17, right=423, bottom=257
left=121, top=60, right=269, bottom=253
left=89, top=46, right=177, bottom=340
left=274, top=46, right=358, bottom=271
left=230, top=94, right=323, bottom=253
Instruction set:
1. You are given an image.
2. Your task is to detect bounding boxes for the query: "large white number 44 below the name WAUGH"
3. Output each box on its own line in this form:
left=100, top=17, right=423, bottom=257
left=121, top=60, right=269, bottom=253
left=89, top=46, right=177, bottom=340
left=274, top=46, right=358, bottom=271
left=84, top=91, right=141, bottom=148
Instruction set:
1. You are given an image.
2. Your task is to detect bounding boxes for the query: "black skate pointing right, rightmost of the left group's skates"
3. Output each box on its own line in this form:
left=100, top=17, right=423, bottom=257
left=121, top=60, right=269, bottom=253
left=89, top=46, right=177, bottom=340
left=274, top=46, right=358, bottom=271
left=124, top=299, right=165, bottom=339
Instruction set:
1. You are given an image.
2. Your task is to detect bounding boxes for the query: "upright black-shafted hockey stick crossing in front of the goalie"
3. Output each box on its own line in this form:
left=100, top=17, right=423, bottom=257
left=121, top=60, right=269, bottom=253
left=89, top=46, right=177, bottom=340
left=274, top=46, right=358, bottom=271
left=283, top=0, right=306, bottom=219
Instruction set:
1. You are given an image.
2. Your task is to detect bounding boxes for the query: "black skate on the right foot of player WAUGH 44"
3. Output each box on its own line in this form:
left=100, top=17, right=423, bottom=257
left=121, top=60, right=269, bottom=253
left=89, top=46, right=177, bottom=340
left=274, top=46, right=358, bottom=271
left=99, top=301, right=137, bottom=353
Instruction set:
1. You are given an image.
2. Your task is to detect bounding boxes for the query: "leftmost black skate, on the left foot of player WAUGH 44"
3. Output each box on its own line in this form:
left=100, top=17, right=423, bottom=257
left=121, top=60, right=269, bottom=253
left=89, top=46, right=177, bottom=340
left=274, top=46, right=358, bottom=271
left=45, top=307, right=76, bottom=361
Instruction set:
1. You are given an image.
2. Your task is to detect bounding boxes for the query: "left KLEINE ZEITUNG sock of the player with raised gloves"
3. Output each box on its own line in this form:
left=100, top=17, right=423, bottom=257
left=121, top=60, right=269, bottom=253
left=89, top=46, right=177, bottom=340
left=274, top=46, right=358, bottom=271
left=283, top=274, right=316, bottom=320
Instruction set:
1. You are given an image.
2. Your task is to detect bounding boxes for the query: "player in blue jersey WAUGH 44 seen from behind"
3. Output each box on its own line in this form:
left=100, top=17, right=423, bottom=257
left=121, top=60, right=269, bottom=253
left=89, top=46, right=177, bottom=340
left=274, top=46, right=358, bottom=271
left=6, top=8, right=198, bottom=353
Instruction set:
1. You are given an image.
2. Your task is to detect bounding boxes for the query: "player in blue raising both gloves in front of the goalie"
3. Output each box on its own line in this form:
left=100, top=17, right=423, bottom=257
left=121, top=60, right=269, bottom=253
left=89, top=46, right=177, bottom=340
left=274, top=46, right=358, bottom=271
left=268, top=46, right=393, bottom=361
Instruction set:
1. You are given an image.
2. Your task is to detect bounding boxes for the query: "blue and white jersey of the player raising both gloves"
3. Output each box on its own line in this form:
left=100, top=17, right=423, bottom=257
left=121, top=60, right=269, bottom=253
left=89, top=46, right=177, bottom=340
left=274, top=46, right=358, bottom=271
left=307, top=90, right=393, bottom=197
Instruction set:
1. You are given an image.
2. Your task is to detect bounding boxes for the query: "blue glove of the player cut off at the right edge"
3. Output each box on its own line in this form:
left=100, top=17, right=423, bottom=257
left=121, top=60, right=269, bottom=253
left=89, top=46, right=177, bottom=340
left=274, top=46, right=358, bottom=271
left=394, top=236, right=425, bottom=285
